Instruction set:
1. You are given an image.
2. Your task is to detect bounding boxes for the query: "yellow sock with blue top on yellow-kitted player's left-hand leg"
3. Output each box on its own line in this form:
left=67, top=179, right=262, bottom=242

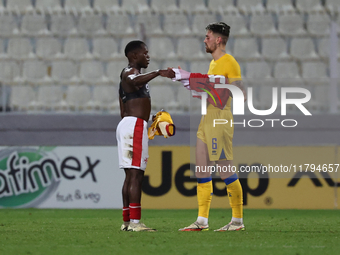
left=197, top=178, right=213, bottom=218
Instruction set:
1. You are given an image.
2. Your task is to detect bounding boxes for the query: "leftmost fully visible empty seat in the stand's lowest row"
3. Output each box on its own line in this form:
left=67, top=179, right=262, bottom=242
left=9, top=86, right=36, bottom=111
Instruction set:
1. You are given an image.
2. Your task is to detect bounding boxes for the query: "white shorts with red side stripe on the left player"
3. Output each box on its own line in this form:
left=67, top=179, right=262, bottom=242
left=116, top=116, right=149, bottom=170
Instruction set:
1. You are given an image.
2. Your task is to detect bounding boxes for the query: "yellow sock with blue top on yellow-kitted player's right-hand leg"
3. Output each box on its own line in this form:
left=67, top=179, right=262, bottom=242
left=227, top=179, right=243, bottom=218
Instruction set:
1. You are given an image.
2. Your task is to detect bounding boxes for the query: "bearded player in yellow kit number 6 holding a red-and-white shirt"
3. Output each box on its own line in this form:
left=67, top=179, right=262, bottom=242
left=173, top=22, right=246, bottom=231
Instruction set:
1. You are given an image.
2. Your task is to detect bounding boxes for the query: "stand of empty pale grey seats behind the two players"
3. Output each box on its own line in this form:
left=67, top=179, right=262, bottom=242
left=0, top=0, right=334, bottom=113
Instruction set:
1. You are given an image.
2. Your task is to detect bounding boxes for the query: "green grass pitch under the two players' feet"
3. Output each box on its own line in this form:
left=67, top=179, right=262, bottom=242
left=0, top=209, right=340, bottom=255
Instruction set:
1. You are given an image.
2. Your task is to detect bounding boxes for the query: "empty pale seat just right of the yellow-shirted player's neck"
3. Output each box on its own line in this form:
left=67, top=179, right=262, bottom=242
left=233, top=38, right=260, bottom=60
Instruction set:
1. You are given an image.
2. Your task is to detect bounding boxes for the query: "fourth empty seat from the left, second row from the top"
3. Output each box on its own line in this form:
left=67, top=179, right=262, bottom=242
left=78, top=14, right=106, bottom=36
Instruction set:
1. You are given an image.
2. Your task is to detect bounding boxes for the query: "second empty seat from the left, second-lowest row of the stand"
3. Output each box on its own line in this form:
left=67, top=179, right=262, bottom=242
left=23, top=60, right=50, bottom=84
